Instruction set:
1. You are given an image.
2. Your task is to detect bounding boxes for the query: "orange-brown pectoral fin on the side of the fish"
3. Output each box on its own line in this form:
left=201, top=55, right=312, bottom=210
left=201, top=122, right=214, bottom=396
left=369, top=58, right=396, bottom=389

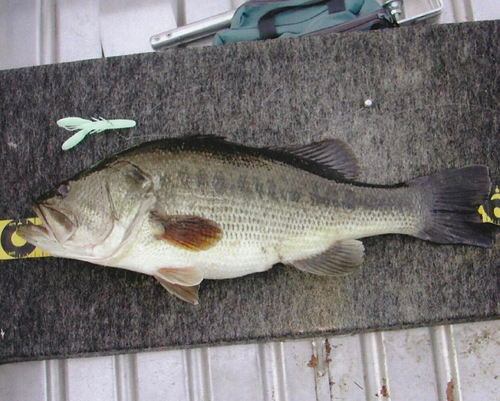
left=152, top=213, right=222, bottom=251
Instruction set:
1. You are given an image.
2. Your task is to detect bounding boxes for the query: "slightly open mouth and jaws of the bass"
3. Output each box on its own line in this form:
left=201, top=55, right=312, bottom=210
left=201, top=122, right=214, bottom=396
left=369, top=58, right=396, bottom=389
left=17, top=203, right=77, bottom=245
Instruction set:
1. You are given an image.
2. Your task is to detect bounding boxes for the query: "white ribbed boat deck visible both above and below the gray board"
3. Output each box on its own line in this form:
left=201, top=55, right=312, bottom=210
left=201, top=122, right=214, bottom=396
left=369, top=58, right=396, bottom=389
left=0, top=0, right=500, bottom=401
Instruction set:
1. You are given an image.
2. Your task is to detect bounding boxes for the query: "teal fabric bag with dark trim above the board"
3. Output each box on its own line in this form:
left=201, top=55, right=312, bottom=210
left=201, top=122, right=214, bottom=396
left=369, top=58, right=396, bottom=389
left=213, top=0, right=397, bottom=45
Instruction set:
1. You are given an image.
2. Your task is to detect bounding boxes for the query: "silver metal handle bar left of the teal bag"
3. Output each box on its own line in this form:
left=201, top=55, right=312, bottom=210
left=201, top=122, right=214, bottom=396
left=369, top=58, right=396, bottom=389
left=150, top=10, right=236, bottom=50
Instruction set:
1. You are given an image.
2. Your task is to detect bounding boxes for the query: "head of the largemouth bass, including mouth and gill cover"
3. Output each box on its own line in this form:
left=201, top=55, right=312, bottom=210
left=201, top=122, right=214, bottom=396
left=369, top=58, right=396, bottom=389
left=18, top=161, right=154, bottom=264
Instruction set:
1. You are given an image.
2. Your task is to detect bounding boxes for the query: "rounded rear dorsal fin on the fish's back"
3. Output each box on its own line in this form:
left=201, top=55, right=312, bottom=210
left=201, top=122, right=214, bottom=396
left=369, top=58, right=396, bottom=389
left=274, top=139, right=360, bottom=181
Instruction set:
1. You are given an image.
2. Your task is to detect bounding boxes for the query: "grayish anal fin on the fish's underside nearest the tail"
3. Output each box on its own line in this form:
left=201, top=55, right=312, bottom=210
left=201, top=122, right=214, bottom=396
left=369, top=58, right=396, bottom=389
left=291, top=240, right=365, bottom=276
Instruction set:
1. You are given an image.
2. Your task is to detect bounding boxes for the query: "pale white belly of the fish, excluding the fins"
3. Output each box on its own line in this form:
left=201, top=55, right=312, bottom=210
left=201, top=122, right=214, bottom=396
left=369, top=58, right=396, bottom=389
left=110, top=202, right=418, bottom=279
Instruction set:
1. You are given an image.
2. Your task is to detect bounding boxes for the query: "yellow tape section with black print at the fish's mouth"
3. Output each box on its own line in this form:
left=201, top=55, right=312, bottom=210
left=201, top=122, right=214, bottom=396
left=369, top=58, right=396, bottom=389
left=0, top=217, right=50, bottom=260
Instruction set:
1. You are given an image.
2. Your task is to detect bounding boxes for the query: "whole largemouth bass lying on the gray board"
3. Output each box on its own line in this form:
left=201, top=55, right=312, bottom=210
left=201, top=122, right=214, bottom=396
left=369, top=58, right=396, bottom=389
left=19, top=137, right=494, bottom=303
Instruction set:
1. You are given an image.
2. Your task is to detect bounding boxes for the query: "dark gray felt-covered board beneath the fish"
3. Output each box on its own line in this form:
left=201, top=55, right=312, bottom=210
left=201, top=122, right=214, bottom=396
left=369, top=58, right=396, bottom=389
left=0, top=21, right=500, bottom=362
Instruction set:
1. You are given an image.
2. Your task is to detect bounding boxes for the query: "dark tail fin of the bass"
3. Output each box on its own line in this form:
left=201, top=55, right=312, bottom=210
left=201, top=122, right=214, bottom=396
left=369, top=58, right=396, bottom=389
left=407, top=165, right=495, bottom=247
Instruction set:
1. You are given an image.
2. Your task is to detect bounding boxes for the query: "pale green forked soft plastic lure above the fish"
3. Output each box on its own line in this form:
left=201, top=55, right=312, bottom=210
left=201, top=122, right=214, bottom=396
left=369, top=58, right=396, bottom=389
left=57, top=117, right=136, bottom=150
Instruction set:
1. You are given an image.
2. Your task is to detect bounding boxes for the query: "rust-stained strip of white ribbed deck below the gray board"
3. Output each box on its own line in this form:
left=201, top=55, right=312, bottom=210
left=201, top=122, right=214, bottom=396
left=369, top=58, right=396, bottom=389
left=0, top=321, right=500, bottom=401
